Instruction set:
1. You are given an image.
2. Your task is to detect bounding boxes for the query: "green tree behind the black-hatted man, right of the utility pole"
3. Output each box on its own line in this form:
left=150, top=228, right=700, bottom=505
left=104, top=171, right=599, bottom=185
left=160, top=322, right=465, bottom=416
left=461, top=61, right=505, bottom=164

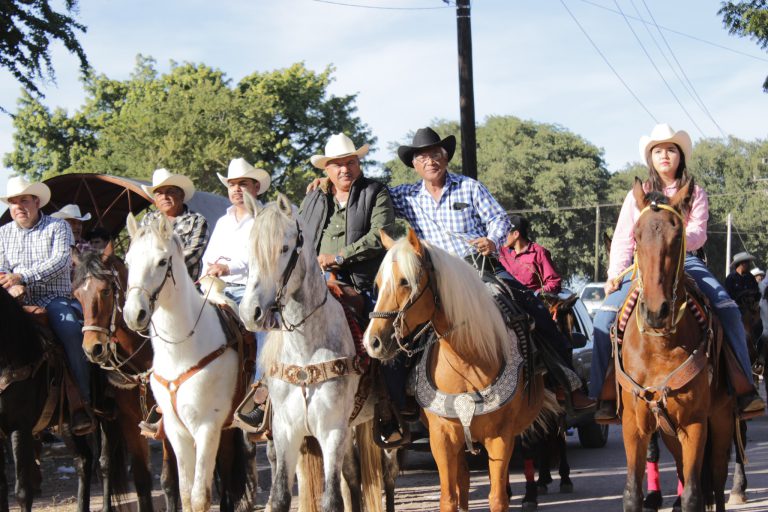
left=386, top=116, right=609, bottom=275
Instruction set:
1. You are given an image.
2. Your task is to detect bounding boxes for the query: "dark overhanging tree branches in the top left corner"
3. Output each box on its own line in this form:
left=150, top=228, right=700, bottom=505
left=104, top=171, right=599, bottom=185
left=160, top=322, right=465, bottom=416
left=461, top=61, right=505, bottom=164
left=0, top=0, right=88, bottom=96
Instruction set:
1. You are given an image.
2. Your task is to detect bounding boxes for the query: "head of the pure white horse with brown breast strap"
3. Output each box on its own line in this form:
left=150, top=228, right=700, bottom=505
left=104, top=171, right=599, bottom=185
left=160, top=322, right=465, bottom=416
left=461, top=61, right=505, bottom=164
left=123, top=214, right=183, bottom=331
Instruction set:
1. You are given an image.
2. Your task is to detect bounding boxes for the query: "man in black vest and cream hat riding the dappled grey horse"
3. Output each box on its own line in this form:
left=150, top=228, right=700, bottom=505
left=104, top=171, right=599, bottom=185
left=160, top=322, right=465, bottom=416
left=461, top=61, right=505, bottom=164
left=241, top=133, right=397, bottom=441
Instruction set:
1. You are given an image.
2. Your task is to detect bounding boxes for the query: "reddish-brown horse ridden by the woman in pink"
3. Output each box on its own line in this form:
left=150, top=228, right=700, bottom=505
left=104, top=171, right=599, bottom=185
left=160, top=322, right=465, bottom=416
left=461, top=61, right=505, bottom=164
left=615, top=180, right=735, bottom=511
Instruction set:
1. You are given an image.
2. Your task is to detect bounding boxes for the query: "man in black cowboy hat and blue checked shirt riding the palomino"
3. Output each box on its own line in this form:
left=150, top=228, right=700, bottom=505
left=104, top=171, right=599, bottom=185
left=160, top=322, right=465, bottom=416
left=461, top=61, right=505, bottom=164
left=385, top=127, right=595, bottom=410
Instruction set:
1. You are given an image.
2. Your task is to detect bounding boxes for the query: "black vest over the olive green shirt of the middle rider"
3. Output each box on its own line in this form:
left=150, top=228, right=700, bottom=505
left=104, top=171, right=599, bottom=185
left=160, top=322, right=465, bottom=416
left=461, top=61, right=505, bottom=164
left=300, top=176, right=389, bottom=291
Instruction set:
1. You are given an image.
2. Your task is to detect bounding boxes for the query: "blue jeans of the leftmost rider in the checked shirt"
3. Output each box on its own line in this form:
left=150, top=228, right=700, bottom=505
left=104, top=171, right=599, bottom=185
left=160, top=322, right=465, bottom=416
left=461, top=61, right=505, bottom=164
left=45, top=297, right=91, bottom=403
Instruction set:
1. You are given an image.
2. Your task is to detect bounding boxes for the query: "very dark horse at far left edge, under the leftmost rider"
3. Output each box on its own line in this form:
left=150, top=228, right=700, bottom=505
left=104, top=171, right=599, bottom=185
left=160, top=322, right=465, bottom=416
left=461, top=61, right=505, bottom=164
left=0, top=287, right=97, bottom=512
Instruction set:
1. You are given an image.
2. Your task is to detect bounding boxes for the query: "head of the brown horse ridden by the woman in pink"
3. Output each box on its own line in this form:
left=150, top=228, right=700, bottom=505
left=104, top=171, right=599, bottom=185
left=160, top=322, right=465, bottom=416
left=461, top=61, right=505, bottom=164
left=633, top=178, right=693, bottom=329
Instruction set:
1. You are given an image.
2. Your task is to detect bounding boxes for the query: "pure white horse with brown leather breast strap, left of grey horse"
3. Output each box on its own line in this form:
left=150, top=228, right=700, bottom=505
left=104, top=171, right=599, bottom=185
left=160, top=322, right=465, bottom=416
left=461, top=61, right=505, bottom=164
left=123, top=215, right=239, bottom=512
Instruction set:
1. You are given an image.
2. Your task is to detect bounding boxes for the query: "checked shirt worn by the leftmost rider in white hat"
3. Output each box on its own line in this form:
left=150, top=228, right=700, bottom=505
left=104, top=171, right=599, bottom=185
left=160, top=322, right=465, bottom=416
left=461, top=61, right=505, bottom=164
left=0, top=212, right=75, bottom=307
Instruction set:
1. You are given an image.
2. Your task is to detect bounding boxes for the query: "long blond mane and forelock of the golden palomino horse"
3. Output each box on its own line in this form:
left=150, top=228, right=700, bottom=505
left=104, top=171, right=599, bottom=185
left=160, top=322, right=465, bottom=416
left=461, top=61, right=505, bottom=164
left=388, top=238, right=510, bottom=364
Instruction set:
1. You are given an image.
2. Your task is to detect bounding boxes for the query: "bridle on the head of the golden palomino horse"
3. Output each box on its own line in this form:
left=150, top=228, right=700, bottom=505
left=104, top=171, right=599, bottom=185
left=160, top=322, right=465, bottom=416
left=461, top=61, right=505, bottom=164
left=368, top=249, right=448, bottom=357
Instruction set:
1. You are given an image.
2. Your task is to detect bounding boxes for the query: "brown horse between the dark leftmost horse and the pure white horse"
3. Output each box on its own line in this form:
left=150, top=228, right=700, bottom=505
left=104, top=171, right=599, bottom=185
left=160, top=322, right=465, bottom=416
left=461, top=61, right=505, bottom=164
left=74, top=250, right=258, bottom=510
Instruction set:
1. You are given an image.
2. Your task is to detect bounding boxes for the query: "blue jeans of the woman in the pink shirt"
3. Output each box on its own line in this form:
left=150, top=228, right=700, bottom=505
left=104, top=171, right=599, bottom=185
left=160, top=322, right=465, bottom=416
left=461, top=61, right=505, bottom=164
left=589, top=255, right=752, bottom=398
